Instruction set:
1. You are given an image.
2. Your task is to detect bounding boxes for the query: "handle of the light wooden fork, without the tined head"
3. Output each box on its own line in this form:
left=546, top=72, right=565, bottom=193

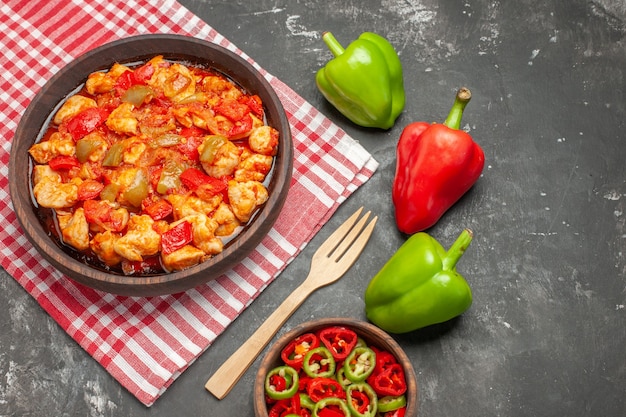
left=204, top=280, right=314, bottom=400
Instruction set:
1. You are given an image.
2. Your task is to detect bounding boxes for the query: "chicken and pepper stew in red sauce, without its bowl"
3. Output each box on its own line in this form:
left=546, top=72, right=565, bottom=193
left=29, top=56, right=279, bottom=275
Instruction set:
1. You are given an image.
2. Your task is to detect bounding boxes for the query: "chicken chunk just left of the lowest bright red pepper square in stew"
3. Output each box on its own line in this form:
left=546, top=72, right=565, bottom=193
left=113, top=214, right=161, bottom=261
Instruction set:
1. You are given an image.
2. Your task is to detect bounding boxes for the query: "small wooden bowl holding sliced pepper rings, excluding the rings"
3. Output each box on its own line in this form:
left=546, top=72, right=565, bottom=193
left=254, top=318, right=418, bottom=417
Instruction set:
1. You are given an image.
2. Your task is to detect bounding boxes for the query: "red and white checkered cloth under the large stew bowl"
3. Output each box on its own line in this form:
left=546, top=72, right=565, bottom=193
left=0, top=0, right=378, bottom=406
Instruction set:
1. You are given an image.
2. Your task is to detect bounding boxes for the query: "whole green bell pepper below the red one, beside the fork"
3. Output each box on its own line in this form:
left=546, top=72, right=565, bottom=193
left=364, top=229, right=473, bottom=333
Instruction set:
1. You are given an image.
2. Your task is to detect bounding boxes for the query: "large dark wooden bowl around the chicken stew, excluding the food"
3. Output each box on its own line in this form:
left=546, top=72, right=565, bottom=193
left=9, top=34, right=293, bottom=296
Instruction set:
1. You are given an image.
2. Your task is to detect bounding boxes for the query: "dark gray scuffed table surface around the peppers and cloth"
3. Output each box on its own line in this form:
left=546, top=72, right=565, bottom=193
left=0, top=0, right=626, bottom=417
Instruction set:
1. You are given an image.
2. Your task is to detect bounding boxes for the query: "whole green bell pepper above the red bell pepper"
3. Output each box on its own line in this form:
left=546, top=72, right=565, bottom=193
left=315, top=32, right=405, bottom=129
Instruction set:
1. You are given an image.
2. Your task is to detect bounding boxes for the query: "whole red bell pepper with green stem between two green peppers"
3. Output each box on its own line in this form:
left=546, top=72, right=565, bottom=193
left=392, top=88, right=485, bottom=234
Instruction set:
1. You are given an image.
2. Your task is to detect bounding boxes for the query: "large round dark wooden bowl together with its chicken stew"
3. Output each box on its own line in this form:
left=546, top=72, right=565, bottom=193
left=9, top=34, right=293, bottom=296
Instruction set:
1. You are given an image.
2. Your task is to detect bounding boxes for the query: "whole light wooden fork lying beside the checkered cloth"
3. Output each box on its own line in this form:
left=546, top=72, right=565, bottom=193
left=204, top=207, right=378, bottom=400
